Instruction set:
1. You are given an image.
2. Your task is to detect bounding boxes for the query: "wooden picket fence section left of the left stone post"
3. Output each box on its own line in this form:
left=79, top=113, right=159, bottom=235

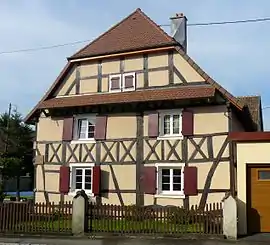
left=0, top=202, right=72, bottom=233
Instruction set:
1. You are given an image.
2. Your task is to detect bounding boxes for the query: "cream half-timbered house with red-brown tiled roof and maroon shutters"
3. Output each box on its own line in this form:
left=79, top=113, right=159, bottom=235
left=26, top=9, right=263, bottom=234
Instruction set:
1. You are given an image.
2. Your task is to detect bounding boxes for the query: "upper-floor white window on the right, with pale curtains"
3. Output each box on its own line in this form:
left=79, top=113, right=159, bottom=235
left=159, top=110, right=182, bottom=137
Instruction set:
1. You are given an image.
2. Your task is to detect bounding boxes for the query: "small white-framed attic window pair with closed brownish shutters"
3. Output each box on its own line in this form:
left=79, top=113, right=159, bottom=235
left=109, top=72, right=136, bottom=92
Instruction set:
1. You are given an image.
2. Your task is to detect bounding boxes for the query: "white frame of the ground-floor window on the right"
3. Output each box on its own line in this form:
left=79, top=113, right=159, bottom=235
left=155, top=163, right=185, bottom=198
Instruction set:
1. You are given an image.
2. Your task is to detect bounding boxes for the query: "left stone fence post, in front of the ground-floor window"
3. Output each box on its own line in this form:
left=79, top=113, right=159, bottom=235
left=72, top=190, right=88, bottom=236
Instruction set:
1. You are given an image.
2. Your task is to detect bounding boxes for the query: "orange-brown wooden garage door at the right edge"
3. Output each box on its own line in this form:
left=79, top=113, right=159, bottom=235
left=247, top=165, right=270, bottom=233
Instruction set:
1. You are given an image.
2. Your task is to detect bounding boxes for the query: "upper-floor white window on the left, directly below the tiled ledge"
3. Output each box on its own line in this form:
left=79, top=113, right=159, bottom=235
left=74, top=116, right=95, bottom=140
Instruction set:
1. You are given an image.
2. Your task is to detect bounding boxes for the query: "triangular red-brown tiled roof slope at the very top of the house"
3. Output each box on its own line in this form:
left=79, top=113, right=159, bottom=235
left=69, top=8, right=179, bottom=59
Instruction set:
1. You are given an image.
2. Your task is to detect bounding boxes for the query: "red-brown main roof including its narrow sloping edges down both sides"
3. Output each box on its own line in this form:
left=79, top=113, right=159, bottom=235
left=25, top=9, right=250, bottom=122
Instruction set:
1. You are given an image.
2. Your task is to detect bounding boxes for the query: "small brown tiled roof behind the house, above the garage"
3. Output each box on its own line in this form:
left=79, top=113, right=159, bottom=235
left=237, top=96, right=263, bottom=128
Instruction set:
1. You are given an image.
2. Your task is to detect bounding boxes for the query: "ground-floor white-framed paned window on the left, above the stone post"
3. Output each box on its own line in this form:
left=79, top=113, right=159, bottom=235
left=70, top=164, right=93, bottom=194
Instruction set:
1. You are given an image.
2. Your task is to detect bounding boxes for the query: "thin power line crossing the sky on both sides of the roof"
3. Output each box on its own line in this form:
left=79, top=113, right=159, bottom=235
left=0, top=17, right=270, bottom=55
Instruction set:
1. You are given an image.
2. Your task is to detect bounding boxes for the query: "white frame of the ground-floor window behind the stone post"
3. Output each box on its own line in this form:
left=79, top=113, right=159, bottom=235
left=68, top=163, right=95, bottom=196
